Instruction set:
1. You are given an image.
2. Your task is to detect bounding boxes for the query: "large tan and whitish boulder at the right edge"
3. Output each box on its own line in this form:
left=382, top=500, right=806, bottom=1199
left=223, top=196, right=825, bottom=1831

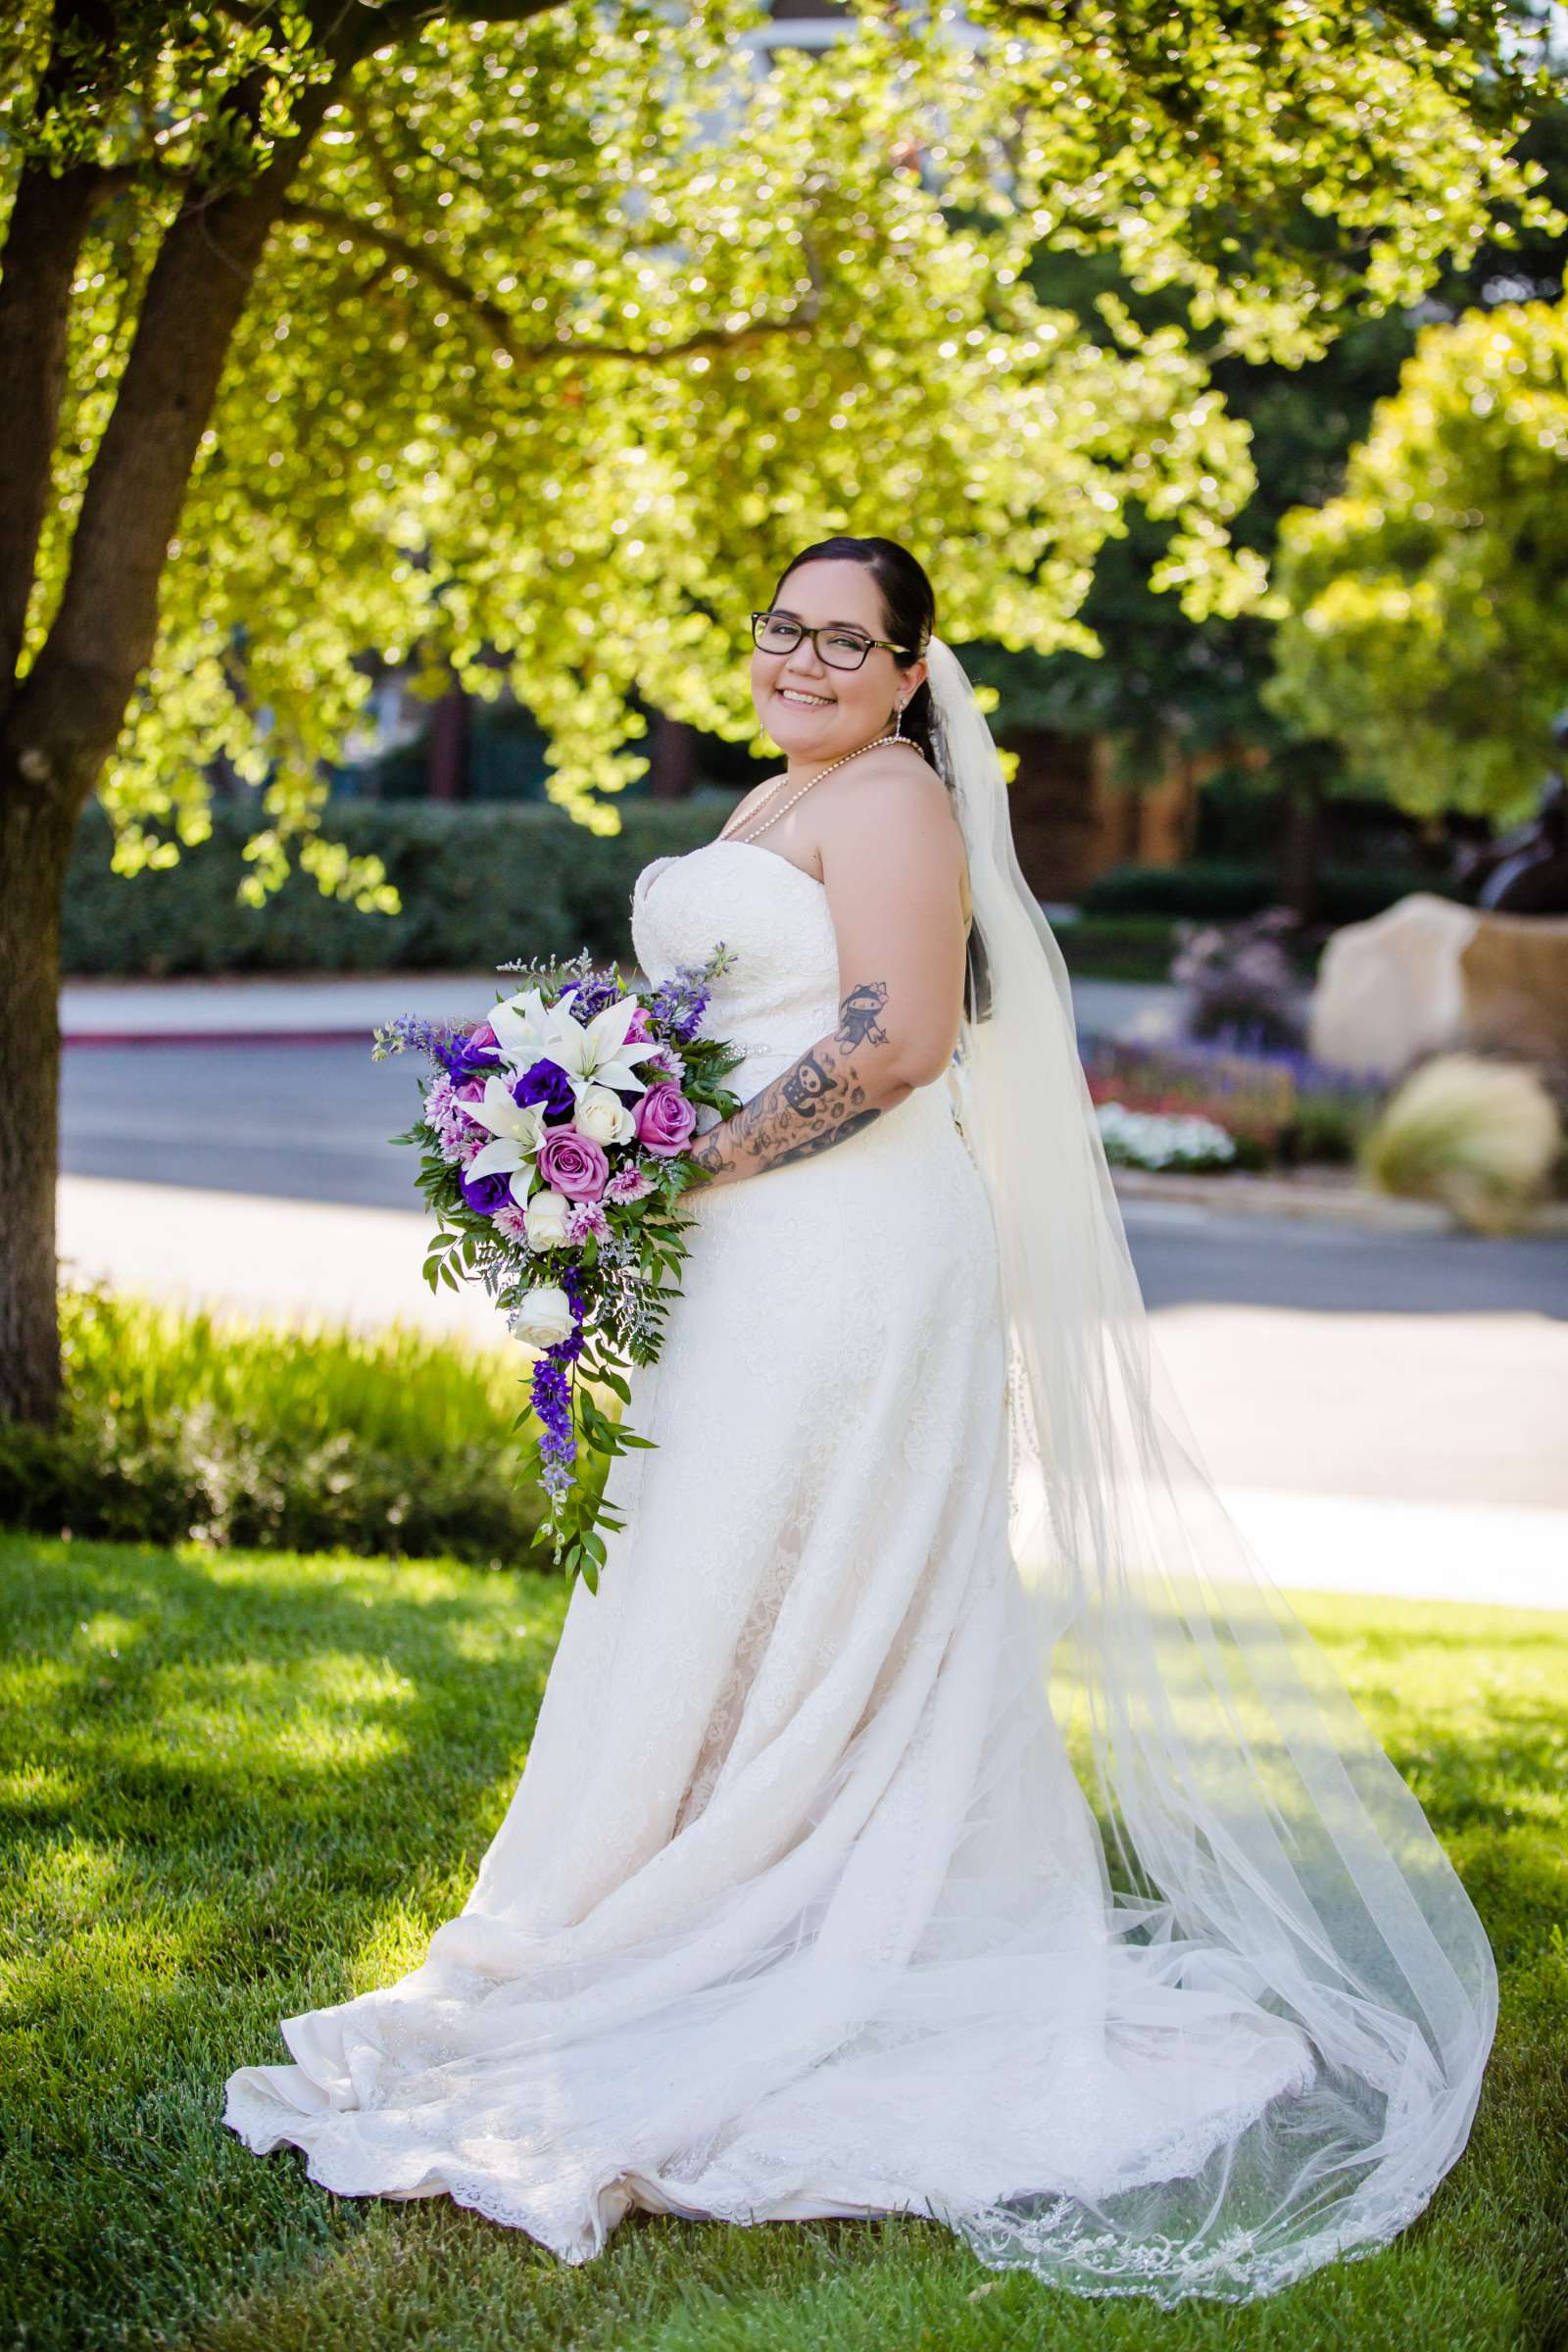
left=1307, top=892, right=1568, bottom=1077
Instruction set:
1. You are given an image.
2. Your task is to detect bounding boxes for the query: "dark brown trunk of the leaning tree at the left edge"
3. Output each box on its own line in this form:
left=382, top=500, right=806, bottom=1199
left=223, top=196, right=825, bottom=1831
left=0, top=69, right=350, bottom=1423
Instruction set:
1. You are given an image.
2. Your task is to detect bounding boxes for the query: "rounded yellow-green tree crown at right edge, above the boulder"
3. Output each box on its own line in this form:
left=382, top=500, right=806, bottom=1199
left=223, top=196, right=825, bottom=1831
left=1267, top=301, right=1568, bottom=821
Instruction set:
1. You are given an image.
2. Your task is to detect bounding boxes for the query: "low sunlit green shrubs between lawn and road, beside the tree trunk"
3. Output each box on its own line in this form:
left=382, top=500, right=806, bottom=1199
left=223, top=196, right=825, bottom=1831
left=0, top=1287, right=552, bottom=1566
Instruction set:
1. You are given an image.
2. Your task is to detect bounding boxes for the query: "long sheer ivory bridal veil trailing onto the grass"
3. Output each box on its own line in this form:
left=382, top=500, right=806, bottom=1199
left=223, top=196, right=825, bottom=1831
left=926, top=637, right=1497, bottom=2303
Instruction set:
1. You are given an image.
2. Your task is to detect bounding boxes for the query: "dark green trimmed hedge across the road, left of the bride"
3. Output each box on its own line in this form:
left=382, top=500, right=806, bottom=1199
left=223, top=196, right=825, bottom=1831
left=61, top=793, right=733, bottom=978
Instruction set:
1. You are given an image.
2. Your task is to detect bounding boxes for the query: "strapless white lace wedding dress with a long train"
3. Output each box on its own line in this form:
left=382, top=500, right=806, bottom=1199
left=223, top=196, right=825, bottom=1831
left=223, top=842, right=1312, bottom=2275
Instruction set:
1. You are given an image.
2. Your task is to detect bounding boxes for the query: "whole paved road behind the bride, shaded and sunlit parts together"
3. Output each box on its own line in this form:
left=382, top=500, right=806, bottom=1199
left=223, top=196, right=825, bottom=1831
left=61, top=976, right=1568, bottom=1606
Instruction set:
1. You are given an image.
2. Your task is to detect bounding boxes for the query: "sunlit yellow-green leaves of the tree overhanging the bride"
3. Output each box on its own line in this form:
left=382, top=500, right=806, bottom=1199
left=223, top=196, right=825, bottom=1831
left=0, top=0, right=1540, bottom=906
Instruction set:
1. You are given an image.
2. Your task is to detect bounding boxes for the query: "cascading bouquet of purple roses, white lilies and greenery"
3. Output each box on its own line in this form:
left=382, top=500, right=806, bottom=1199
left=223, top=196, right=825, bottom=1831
left=371, top=941, right=745, bottom=1592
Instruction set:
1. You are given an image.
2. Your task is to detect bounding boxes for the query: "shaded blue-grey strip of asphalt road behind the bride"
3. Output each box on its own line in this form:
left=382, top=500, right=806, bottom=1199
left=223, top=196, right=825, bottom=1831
left=61, top=1045, right=1568, bottom=1317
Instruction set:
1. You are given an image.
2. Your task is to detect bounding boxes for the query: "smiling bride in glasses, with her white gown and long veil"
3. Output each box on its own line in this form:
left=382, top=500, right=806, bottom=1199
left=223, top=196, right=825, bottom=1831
left=223, top=539, right=1495, bottom=2303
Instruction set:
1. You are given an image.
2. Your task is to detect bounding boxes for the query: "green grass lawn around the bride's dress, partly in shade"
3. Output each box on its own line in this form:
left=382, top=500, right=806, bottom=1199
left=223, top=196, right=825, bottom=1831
left=0, top=1536, right=1568, bottom=2352
